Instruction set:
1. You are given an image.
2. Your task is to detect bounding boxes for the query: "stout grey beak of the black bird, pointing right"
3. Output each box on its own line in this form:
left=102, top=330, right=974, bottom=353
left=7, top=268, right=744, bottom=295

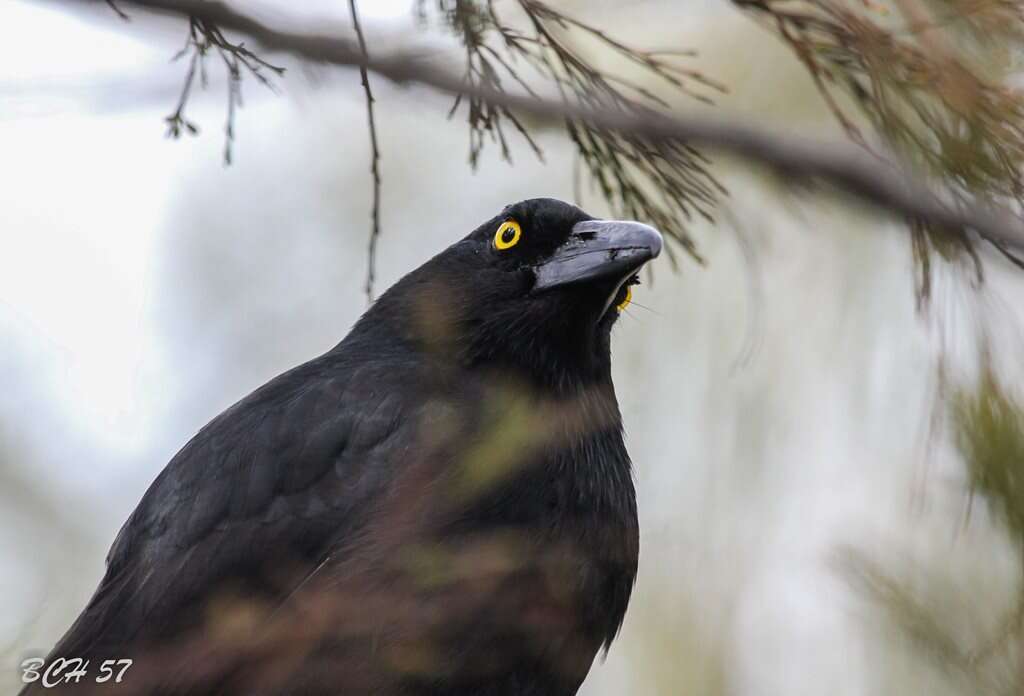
left=534, top=220, right=662, bottom=291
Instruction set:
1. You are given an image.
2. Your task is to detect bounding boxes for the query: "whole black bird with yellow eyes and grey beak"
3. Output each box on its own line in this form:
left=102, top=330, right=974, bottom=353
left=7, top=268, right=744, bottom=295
left=29, top=199, right=662, bottom=696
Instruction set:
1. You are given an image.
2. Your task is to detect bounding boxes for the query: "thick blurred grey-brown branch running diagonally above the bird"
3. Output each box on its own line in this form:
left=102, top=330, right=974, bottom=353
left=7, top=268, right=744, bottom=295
left=80, top=0, right=1024, bottom=251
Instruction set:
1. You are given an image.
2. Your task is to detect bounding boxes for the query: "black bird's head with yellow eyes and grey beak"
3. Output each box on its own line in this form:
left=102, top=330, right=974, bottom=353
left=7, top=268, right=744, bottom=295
left=360, top=199, right=662, bottom=388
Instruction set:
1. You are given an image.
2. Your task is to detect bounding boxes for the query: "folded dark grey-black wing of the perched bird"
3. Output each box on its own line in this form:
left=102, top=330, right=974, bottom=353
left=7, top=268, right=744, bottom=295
left=51, top=358, right=415, bottom=657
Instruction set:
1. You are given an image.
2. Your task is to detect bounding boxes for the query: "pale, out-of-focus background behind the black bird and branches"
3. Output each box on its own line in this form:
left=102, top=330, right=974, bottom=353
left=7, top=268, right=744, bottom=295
left=6, top=0, right=1024, bottom=696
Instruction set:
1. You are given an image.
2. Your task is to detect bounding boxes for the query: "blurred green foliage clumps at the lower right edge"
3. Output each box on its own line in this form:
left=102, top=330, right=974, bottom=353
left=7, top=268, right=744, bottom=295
left=838, top=374, right=1024, bottom=695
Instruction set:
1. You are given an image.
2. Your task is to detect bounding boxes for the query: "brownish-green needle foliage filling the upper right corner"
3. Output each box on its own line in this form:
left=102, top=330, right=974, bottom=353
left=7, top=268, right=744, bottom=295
left=733, top=0, right=1024, bottom=299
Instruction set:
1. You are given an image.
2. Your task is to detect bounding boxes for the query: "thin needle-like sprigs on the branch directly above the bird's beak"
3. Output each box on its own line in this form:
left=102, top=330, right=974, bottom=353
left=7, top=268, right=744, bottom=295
left=418, top=0, right=726, bottom=261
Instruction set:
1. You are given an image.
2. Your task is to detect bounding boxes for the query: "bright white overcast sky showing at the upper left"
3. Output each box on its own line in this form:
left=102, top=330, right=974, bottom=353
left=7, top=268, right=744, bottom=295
left=0, top=0, right=412, bottom=453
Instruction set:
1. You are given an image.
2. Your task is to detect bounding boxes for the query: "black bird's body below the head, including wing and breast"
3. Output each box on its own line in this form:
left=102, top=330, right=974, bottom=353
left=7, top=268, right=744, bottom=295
left=32, top=344, right=636, bottom=695
